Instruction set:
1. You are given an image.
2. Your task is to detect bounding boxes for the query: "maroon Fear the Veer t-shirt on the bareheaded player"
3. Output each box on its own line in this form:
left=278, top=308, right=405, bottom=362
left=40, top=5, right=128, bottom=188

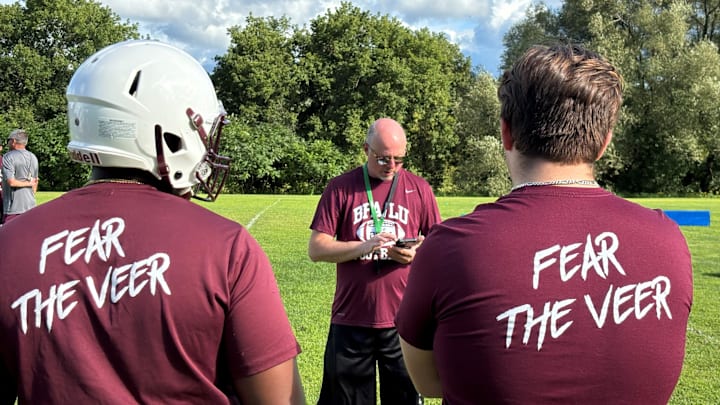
left=397, top=187, right=692, bottom=405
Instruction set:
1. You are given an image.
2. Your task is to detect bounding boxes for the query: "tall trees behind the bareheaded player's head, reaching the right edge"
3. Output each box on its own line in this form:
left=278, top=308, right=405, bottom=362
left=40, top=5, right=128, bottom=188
left=506, top=0, right=720, bottom=194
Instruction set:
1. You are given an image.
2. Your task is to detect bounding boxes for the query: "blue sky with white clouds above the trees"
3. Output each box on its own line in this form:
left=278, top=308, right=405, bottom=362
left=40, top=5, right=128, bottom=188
left=0, top=0, right=562, bottom=75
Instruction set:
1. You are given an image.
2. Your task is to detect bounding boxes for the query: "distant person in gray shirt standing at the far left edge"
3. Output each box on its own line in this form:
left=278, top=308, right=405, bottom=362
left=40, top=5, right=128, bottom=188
left=2, top=129, right=39, bottom=223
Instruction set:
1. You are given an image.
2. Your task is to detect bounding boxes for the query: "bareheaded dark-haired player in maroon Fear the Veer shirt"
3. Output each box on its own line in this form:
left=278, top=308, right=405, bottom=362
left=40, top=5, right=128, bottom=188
left=396, top=45, right=692, bottom=405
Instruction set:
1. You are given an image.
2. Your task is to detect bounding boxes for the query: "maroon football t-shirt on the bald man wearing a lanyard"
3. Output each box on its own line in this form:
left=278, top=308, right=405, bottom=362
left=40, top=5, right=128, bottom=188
left=310, top=167, right=440, bottom=328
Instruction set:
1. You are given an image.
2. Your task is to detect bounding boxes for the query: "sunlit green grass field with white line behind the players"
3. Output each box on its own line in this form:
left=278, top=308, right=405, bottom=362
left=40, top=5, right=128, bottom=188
left=32, top=193, right=720, bottom=405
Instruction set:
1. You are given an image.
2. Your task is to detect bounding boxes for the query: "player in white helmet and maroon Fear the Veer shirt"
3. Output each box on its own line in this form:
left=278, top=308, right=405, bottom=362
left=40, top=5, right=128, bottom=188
left=0, top=41, right=304, bottom=404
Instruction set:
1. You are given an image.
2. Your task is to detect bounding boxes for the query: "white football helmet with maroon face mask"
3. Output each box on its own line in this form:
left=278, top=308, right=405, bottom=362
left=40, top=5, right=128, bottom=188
left=66, top=40, right=230, bottom=201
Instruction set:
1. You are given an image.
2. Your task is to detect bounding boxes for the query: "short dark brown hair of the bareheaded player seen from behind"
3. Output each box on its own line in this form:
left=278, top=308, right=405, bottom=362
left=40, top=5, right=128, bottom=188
left=498, top=44, right=623, bottom=164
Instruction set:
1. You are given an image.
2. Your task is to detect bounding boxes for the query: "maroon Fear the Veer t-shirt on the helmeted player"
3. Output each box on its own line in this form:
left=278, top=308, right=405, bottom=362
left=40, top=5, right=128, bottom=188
left=0, top=184, right=300, bottom=404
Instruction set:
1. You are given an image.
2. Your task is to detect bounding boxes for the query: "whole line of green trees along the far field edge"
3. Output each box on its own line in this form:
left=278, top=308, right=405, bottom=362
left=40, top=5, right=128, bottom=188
left=0, top=0, right=720, bottom=195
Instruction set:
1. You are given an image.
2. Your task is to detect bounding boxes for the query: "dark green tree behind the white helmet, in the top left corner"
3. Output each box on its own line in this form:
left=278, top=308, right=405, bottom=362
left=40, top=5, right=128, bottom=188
left=0, top=0, right=138, bottom=122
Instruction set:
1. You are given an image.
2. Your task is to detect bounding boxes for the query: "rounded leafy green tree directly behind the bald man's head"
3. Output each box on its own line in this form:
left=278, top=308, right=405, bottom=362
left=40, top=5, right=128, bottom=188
left=297, top=2, right=472, bottom=187
